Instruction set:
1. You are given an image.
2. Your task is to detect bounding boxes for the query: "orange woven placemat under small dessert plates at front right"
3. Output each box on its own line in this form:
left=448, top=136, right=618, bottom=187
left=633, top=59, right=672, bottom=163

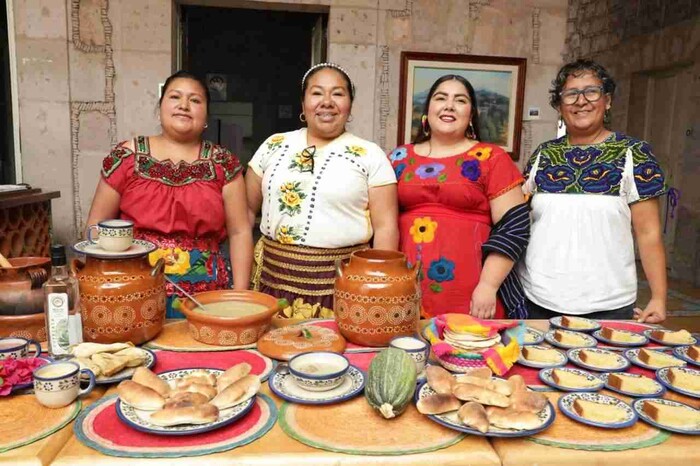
left=527, top=390, right=671, bottom=451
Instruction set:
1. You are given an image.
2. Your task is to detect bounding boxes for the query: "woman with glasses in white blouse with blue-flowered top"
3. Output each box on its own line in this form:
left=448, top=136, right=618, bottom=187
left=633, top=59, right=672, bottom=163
left=519, top=60, right=667, bottom=323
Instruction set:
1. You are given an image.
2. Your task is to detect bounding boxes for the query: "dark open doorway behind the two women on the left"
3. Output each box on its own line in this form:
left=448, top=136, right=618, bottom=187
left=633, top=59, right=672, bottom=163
left=176, top=2, right=328, bottom=166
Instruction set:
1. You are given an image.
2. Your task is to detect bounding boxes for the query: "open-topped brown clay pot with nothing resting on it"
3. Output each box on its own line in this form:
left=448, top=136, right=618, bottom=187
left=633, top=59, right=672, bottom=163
left=333, top=249, right=421, bottom=346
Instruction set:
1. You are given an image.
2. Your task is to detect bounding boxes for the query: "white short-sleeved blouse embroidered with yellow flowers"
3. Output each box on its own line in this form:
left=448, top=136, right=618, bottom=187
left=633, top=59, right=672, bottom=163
left=249, top=128, right=396, bottom=248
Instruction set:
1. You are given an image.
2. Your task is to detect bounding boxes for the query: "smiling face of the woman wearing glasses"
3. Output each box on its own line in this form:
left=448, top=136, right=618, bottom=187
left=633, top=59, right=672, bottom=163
left=559, top=72, right=611, bottom=136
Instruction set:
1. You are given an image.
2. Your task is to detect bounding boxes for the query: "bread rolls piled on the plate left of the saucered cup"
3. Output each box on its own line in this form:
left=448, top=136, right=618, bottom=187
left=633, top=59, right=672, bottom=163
left=117, top=362, right=260, bottom=427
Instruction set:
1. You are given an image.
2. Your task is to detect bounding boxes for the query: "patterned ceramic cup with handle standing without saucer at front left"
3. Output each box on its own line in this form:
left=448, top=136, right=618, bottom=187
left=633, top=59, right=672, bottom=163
left=33, top=361, right=95, bottom=408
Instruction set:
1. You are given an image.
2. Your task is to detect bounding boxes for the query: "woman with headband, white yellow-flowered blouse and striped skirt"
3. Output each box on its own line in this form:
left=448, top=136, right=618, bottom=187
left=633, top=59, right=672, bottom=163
left=246, top=63, right=398, bottom=316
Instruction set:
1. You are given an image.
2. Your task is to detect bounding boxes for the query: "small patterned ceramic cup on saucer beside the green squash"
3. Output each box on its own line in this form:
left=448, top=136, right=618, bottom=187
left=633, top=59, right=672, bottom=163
left=289, top=351, right=350, bottom=392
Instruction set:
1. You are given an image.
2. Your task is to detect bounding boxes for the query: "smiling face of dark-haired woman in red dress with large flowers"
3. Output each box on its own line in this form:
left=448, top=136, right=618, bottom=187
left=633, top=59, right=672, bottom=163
left=428, top=79, right=472, bottom=137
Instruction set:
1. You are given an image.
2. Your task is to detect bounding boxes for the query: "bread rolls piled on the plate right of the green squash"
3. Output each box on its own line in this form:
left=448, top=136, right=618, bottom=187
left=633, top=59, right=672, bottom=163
left=416, top=366, right=548, bottom=433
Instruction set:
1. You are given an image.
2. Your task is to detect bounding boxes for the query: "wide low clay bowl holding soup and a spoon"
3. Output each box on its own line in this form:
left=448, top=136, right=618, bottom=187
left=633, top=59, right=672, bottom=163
left=180, top=290, right=279, bottom=346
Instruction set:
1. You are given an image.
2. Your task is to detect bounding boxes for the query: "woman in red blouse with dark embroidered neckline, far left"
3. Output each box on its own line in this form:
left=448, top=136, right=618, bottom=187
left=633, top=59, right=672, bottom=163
left=88, top=71, right=253, bottom=317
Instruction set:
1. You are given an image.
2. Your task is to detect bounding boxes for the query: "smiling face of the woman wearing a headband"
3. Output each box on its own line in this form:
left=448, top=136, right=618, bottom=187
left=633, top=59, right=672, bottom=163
left=302, top=68, right=352, bottom=140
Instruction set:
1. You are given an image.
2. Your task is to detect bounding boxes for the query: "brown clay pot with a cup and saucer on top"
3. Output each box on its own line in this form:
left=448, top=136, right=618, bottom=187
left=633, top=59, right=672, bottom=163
left=71, top=254, right=165, bottom=345
